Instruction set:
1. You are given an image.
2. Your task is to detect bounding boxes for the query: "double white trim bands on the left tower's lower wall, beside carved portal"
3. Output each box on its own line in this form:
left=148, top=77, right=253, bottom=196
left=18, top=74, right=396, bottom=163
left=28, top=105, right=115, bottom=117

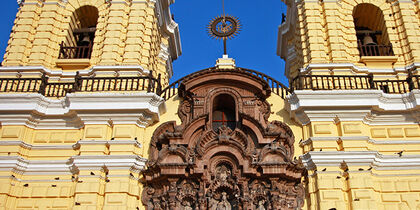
left=0, top=140, right=147, bottom=176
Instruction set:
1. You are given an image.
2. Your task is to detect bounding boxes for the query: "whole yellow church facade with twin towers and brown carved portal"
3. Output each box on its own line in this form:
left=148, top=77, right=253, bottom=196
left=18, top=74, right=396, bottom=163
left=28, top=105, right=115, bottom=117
left=0, top=0, right=420, bottom=210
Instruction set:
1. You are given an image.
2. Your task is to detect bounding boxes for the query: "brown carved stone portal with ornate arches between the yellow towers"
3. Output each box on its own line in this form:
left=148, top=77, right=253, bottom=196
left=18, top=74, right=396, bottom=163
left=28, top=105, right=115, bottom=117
left=142, top=70, right=306, bottom=210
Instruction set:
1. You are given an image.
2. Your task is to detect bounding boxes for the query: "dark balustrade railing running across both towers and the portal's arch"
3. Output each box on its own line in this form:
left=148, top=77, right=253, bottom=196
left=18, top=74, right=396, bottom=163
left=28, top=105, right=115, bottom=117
left=0, top=68, right=420, bottom=100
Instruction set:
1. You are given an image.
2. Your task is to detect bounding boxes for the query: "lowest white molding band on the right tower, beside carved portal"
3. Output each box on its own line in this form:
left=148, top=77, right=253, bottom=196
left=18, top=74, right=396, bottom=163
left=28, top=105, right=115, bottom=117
left=300, top=151, right=420, bottom=173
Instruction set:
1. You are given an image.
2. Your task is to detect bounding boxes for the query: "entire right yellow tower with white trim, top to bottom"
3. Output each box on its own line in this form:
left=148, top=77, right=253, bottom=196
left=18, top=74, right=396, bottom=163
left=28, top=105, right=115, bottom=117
left=277, top=0, right=420, bottom=209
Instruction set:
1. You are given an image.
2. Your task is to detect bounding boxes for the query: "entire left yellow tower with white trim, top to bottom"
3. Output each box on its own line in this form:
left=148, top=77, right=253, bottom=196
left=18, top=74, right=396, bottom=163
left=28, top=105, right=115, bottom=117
left=0, top=0, right=181, bottom=209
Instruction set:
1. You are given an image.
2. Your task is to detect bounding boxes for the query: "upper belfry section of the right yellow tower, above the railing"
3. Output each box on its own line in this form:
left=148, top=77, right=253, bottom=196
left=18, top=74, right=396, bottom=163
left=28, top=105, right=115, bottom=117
left=277, top=0, right=420, bottom=80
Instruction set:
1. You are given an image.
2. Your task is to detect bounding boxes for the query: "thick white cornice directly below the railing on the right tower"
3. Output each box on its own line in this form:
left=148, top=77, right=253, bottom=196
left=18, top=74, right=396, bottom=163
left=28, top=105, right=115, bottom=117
left=286, top=90, right=420, bottom=125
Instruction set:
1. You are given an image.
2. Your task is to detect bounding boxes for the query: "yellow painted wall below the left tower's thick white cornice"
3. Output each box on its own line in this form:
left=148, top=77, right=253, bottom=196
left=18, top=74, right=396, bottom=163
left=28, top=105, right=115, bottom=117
left=0, top=91, right=181, bottom=209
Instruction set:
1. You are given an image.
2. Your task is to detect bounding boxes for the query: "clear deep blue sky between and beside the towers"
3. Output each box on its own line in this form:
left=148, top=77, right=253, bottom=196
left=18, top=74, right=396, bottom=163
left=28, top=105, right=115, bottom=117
left=0, top=0, right=288, bottom=85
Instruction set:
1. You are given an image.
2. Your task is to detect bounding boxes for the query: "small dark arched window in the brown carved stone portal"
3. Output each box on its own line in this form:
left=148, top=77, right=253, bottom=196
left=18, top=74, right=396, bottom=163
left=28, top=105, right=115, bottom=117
left=212, top=94, right=236, bottom=131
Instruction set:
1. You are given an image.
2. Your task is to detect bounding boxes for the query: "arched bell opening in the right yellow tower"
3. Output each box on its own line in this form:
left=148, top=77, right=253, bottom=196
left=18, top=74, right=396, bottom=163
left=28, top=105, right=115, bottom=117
left=353, top=3, right=394, bottom=56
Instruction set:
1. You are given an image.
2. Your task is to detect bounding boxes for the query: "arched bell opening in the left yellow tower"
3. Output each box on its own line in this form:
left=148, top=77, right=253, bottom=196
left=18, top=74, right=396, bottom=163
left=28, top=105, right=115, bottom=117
left=59, top=6, right=99, bottom=59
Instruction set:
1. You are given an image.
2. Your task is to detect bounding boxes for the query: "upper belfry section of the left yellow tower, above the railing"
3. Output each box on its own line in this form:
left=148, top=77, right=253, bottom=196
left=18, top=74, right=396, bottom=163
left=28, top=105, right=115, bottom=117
left=2, top=0, right=181, bottom=84
